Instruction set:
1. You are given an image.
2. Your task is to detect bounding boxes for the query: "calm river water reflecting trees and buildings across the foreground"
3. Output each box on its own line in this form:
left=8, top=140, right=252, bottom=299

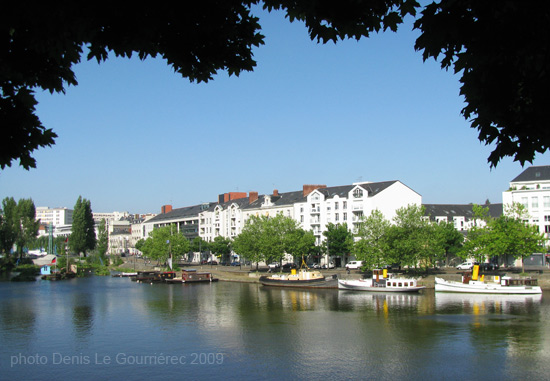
left=0, top=276, right=550, bottom=380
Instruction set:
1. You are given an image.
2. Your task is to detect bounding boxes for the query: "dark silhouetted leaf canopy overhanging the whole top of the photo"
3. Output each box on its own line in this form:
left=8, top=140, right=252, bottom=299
left=4, top=0, right=550, bottom=169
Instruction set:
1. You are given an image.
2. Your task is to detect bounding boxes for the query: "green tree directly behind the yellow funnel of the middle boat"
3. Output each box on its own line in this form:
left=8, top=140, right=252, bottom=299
left=352, top=209, right=391, bottom=269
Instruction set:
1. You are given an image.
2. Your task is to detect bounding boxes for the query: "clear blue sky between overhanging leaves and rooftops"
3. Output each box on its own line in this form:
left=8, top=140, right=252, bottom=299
left=0, top=7, right=550, bottom=213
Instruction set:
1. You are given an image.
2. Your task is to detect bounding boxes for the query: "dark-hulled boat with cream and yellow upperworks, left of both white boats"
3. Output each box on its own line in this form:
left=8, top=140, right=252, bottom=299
left=259, top=269, right=338, bottom=288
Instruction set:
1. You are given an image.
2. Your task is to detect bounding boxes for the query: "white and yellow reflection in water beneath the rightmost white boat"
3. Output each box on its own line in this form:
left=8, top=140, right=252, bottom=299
left=435, top=292, right=542, bottom=315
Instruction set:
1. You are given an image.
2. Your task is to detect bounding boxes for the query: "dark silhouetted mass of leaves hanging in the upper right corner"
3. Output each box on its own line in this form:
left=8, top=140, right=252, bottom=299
left=415, top=0, right=550, bottom=166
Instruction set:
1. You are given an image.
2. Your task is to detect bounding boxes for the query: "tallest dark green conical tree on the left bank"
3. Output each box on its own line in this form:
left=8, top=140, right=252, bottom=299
left=69, top=196, right=96, bottom=256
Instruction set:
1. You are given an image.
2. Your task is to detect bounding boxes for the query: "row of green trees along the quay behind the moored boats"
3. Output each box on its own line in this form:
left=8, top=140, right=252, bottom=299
left=225, top=204, right=545, bottom=270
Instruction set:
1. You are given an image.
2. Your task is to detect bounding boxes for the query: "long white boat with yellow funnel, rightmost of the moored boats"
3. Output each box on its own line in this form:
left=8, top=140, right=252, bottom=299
left=435, top=276, right=542, bottom=295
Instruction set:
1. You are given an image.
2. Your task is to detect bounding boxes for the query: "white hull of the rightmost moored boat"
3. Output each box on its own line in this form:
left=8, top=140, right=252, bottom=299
left=435, top=278, right=542, bottom=295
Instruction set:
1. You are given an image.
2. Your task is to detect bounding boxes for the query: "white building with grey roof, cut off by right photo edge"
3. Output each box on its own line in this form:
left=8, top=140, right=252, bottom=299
left=502, top=165, right=550, bottom=239
